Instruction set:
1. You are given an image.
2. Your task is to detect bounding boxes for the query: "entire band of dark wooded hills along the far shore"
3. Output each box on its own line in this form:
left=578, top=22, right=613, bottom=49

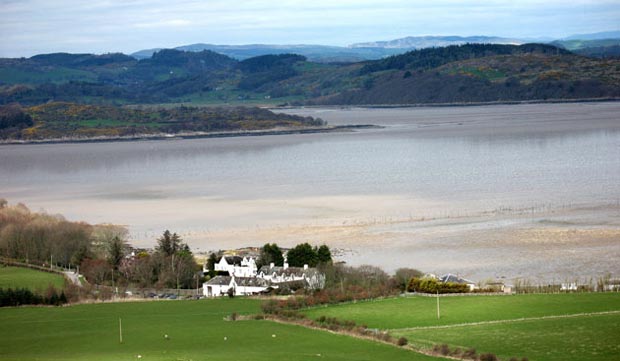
left=0, top=44, right=620, bottom=106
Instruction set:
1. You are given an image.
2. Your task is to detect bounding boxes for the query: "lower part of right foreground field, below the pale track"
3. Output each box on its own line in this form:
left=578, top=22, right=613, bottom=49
left=394, top=314, right=620, bottom=361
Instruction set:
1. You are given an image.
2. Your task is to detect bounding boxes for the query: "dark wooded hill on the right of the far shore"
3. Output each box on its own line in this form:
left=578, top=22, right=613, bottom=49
left=312, top=44, right=620, bottom=104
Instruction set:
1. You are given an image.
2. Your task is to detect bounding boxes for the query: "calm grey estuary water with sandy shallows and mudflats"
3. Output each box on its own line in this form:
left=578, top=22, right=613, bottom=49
left=0, top=102, right=620, bottom=278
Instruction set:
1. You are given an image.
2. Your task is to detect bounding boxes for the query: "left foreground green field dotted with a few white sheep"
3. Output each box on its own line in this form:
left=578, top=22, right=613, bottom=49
left=0, top=298, right=431, bottom=361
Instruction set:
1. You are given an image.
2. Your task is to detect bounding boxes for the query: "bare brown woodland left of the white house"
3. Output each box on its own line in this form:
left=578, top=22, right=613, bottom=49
left=0, top=199, right=200, bottom=288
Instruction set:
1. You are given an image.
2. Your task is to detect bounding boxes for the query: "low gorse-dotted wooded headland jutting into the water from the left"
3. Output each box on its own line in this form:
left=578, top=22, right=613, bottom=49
left=0, top=102, right=324, bottom=140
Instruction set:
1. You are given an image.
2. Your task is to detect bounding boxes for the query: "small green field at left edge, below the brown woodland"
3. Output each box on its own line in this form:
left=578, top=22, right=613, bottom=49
left=0, top=266, right=65, bottom=292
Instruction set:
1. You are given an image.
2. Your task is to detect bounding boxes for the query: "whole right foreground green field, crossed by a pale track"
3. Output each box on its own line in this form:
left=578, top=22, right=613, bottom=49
left=304, top=293, right=620, bottom=361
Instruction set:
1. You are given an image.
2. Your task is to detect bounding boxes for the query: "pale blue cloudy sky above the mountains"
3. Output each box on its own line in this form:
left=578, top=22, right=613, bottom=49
left=0, top=0, right=620, bottom=57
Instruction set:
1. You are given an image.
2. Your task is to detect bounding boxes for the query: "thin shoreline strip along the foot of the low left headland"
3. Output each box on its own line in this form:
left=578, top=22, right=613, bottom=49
left=0, top=124, right=383, bottom=146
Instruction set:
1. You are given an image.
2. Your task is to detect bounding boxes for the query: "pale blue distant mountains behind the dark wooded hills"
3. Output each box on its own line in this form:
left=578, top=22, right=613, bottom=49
left=130, top=31, right=620, bottom=63
